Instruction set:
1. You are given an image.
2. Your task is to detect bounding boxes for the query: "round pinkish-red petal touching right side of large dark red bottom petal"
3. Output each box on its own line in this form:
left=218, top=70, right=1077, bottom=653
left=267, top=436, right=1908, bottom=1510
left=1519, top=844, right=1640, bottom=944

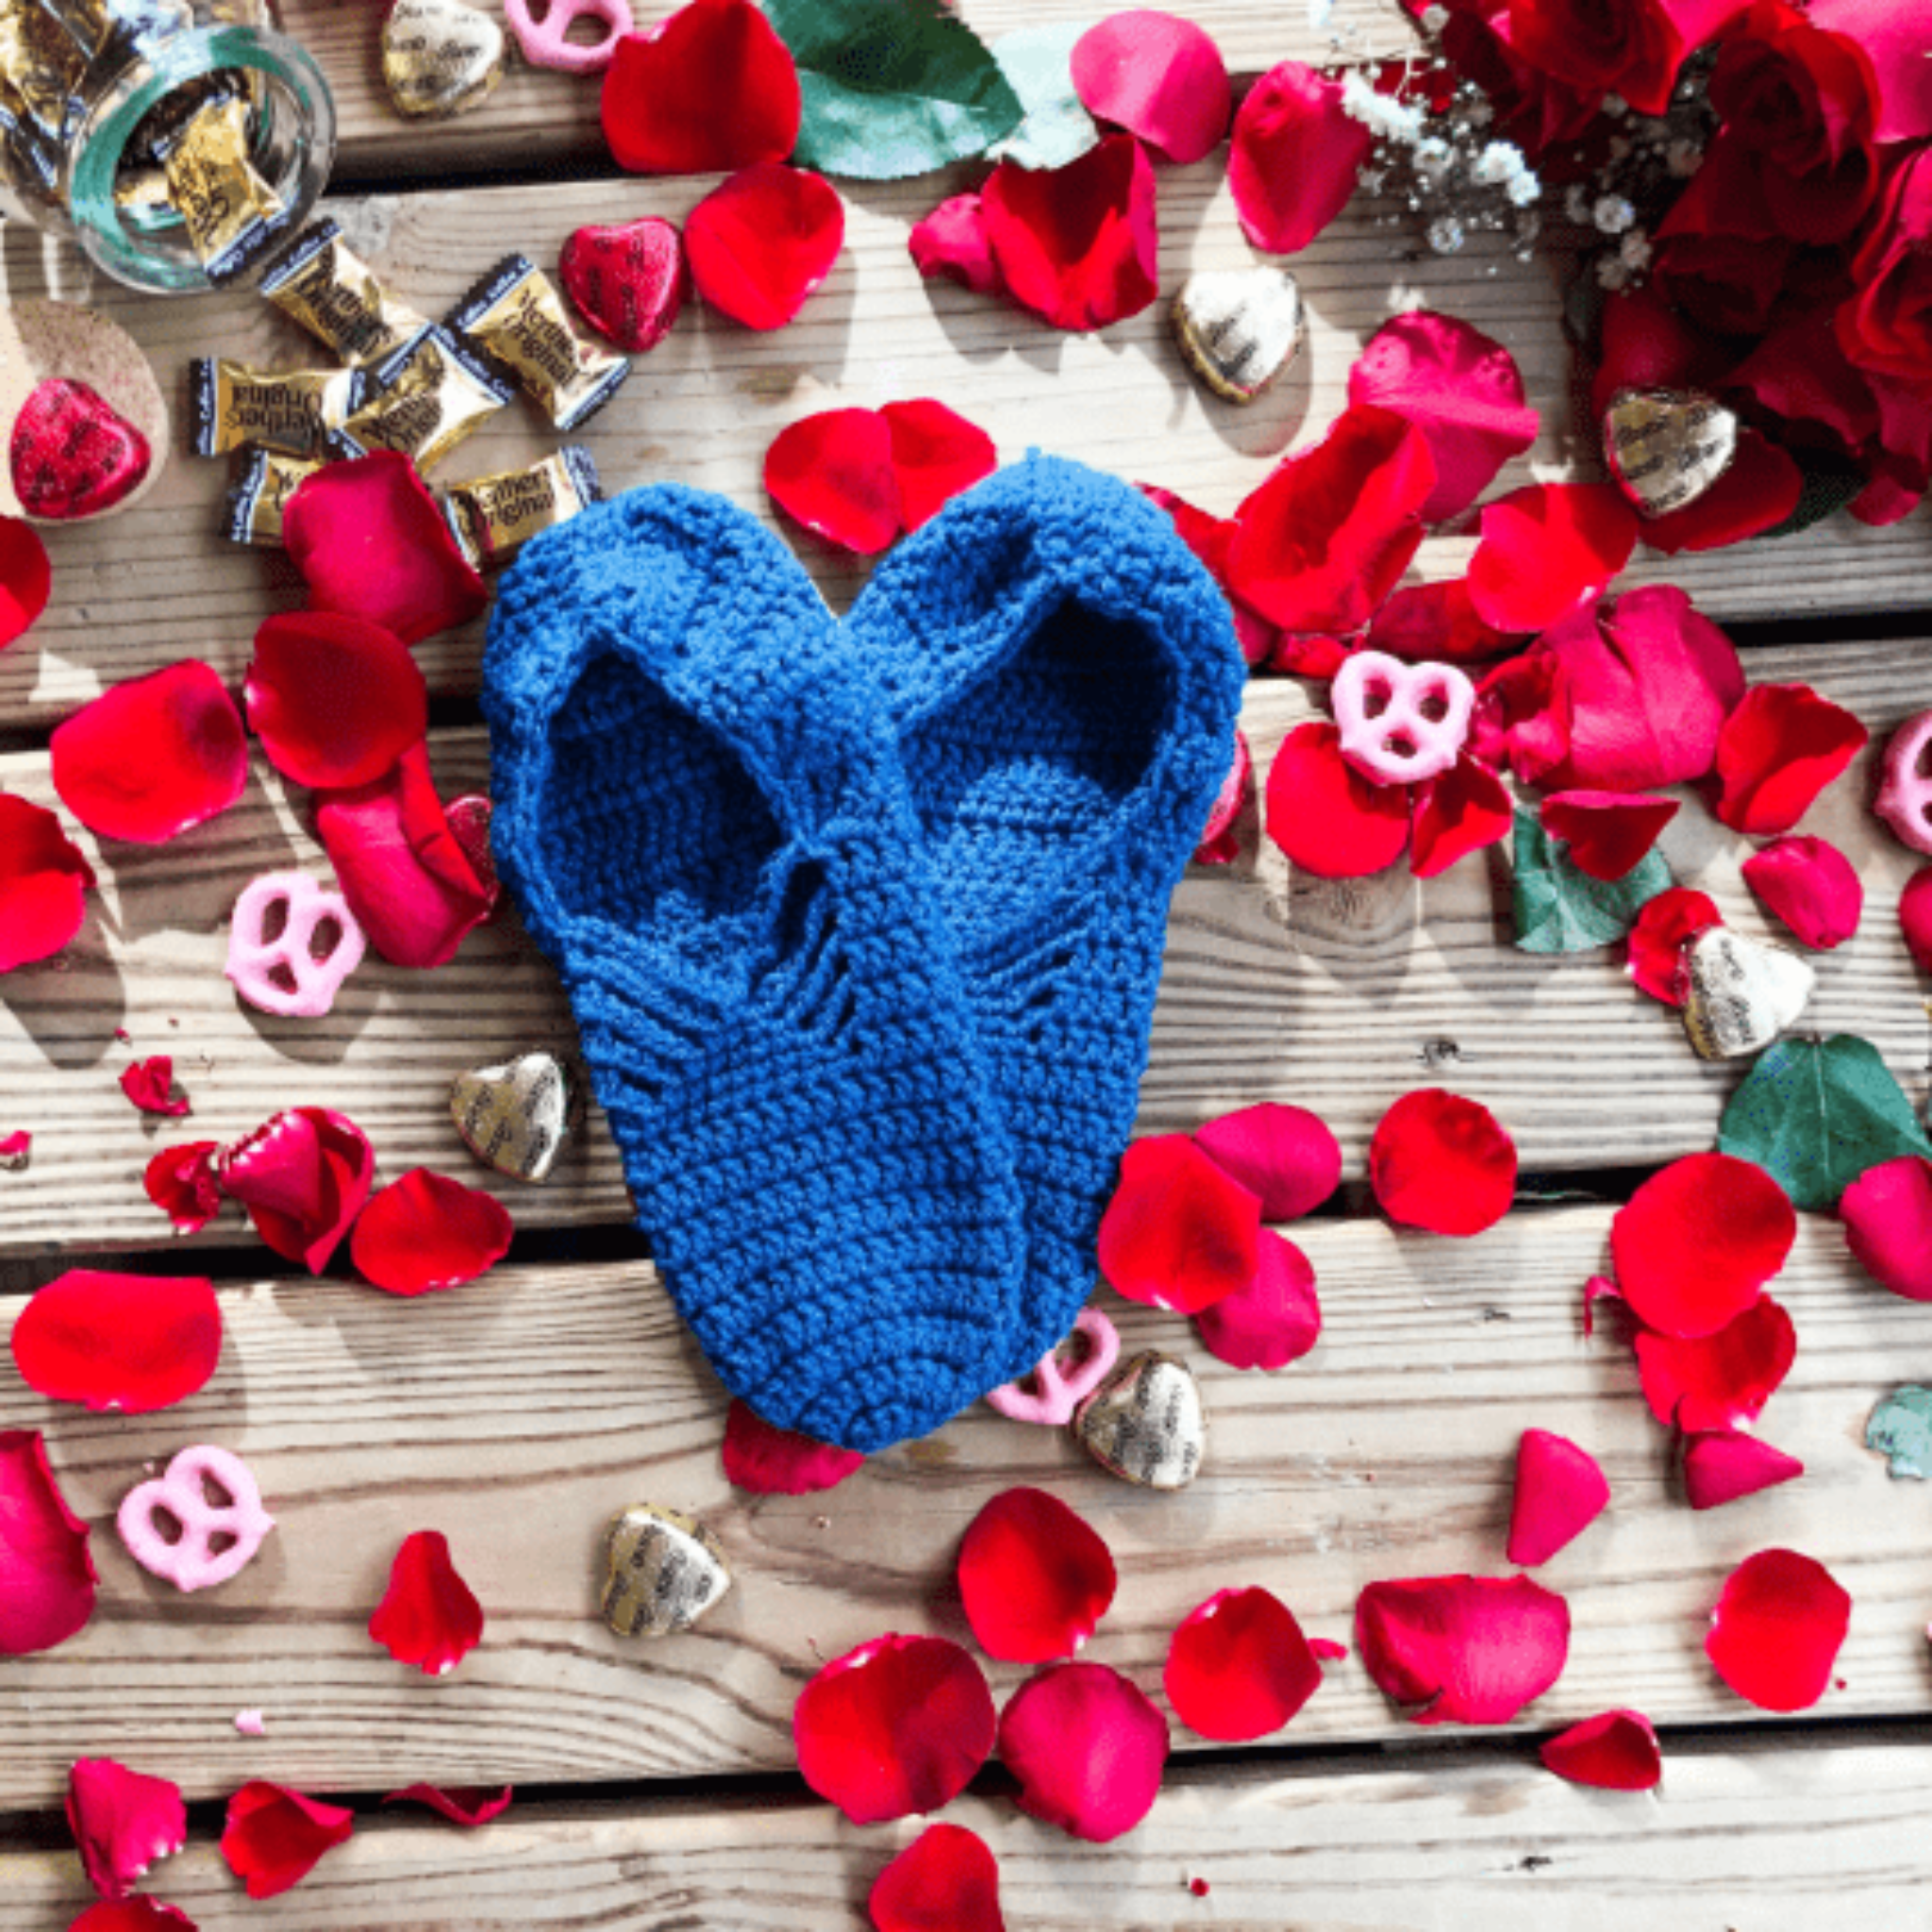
left=999, top=1663, right=1167, bottom=1845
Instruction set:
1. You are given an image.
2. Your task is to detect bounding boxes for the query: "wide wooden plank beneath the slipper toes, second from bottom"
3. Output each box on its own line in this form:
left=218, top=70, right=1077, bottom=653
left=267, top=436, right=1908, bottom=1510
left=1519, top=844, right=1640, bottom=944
left=0, top=1209, right=1932, bottom=1810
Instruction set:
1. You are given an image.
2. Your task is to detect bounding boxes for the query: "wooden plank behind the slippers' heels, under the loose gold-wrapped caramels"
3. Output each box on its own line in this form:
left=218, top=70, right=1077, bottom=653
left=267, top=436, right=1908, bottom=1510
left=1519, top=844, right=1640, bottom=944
left=0, top=159, right=1928, bottom=728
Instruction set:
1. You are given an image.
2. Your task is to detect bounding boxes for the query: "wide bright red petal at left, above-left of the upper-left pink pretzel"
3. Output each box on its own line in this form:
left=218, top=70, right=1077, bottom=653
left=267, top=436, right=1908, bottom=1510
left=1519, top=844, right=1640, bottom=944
left=50, top=657, right=247, bottom=844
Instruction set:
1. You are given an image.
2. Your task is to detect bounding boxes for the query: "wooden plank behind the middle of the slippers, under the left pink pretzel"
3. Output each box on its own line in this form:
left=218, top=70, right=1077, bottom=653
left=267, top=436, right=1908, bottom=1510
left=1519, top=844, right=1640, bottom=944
left=0, top=643, right=1932, bottom=1252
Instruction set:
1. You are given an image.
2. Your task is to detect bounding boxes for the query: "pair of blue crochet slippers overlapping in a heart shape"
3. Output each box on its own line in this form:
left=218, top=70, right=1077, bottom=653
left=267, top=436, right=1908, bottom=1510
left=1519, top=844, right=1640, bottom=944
left=483, top=456, right=1244, bottom=1451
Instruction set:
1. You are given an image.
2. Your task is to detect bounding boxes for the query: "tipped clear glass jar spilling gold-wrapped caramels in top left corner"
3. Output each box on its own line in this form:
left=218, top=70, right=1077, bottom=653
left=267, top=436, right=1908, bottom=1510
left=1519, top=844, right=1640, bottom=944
left=0, top=0, right=336, bottom=291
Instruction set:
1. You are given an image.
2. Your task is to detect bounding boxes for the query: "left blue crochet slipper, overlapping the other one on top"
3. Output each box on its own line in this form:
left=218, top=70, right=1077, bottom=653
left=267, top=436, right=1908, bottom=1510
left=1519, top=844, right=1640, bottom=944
left=483, top=485, right=1030, bottom=1451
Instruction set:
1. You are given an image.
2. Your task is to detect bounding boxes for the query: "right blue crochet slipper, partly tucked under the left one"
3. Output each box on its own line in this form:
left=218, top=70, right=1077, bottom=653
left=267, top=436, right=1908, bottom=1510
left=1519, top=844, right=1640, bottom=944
left=846, top=456, right=1246, bottom=1379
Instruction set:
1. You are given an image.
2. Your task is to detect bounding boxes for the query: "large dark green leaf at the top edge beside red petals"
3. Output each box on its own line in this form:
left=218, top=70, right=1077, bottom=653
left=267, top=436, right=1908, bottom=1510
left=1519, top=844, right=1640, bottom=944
left=765, top=0, right=1024, bottom=182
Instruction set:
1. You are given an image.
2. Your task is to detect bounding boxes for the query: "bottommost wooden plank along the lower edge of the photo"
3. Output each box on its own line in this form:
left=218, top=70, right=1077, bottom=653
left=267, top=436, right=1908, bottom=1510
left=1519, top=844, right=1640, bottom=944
left=0, top=1739, right=1932, bottom=1932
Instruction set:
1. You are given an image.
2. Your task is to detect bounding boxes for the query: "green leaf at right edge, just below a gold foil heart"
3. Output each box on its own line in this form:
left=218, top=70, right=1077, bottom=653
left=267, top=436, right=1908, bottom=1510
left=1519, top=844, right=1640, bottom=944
left=1718, top=1034, right=1932, bottom=1213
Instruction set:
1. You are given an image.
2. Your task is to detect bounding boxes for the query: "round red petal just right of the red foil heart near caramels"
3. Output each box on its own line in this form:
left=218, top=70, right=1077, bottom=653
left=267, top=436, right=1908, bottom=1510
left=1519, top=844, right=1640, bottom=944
left=684, top=160, right=844, bottom=328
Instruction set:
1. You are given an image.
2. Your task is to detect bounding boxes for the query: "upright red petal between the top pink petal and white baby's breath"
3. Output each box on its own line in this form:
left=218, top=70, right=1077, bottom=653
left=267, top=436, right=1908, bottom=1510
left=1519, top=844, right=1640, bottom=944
left=1226, top=59, right=1375, bottom=255
